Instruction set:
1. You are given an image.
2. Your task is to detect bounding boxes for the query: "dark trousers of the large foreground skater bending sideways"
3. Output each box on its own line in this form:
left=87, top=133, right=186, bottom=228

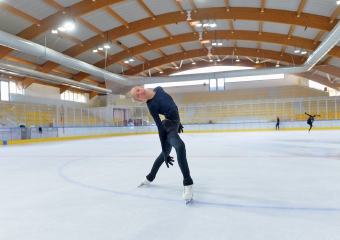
left=146, top=122, right=193, bottom=186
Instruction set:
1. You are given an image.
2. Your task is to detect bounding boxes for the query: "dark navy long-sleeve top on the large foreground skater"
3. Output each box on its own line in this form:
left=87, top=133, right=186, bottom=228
left=146, top=87, right=180, bottom=152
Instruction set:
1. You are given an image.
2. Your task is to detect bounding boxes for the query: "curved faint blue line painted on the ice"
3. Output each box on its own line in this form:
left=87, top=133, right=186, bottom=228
left=58, top=158, right=340, bottom=211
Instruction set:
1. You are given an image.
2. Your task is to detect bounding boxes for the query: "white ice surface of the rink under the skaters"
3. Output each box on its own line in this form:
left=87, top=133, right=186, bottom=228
left=0, top=130, right=340, bottom=240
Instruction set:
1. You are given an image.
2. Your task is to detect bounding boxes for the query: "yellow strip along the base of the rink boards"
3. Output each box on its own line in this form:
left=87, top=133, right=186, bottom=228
left=0, top=127, right=340, bottom=145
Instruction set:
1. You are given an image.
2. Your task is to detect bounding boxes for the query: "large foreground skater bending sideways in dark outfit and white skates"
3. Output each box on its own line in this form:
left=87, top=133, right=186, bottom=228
left=131, top=86, right=193, bottom=204
